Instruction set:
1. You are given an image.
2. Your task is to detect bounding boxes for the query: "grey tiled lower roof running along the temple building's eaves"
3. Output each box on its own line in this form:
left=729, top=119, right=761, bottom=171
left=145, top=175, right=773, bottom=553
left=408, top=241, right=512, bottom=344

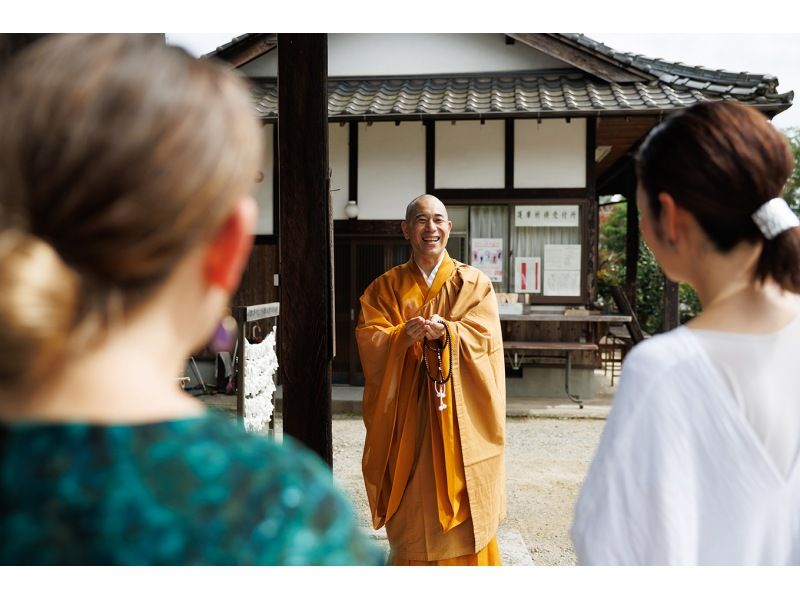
left=253, top=69, right=793, bottom=120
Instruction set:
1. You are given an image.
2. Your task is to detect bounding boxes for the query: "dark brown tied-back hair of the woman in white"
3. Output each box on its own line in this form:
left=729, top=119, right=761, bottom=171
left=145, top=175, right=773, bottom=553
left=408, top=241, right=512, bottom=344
left=636, top=100, right=800, bottom=292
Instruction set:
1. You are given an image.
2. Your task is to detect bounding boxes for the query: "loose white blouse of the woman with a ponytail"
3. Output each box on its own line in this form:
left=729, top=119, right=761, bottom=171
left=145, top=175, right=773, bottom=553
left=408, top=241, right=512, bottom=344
left=572, top=322, right=800, bottom=565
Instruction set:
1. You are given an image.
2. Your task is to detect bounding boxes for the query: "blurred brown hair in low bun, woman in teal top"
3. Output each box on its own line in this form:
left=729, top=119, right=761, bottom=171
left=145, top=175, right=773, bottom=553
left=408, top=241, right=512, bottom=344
left=0, top=35, right=262, bottom=388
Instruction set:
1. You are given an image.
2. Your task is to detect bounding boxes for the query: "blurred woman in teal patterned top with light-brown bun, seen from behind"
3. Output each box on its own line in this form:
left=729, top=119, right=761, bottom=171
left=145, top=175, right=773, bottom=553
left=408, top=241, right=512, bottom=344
left=0, top=35, right=383, bottom=565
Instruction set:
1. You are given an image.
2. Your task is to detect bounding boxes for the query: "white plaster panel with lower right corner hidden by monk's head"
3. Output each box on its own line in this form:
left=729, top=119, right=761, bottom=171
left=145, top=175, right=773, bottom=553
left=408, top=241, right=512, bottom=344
left=358, top=122, right=425, bottom=220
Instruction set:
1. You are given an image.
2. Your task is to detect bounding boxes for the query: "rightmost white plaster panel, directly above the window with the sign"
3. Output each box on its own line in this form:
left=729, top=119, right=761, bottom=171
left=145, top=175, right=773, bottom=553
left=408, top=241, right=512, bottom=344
left=514, top=118, right=586, bottom=188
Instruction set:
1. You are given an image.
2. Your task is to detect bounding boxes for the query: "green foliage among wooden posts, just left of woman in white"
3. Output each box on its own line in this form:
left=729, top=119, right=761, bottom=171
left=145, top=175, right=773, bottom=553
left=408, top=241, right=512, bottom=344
left=597, top=204, right=700, bottom=334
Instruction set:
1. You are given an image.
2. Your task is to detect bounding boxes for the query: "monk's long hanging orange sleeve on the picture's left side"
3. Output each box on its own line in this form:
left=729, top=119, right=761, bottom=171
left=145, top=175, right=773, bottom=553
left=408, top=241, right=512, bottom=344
left=356, top=279, right=420, bottom=529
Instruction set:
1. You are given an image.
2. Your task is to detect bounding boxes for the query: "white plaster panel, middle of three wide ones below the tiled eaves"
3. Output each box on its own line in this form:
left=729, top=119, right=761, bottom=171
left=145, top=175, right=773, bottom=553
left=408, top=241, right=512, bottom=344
left=434, top=120, right=506, bottom=189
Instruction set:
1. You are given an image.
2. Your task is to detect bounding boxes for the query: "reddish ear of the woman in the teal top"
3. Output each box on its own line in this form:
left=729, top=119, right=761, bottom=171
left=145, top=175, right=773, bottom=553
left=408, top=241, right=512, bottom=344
left=204, top=197, right=258, bottom=293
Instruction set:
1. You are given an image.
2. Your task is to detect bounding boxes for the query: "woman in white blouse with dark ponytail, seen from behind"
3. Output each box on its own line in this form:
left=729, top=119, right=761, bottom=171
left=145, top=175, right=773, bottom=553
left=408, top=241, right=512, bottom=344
left=572, top=101, right=800, bottom=565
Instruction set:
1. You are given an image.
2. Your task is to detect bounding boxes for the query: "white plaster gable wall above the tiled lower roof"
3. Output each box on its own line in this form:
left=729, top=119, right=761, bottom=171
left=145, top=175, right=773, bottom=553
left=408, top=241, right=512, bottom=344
left=241, top=33, right=573, bottom=77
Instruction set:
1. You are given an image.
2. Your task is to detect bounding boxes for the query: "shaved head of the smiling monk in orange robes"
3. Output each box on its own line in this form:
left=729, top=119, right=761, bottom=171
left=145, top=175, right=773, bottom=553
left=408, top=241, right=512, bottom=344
left=401, top=195, right=453, bottom=261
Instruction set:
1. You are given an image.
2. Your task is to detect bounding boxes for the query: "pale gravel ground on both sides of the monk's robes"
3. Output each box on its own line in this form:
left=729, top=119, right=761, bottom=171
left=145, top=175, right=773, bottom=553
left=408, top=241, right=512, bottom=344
left=333, top=416, right=605, bottom=565
